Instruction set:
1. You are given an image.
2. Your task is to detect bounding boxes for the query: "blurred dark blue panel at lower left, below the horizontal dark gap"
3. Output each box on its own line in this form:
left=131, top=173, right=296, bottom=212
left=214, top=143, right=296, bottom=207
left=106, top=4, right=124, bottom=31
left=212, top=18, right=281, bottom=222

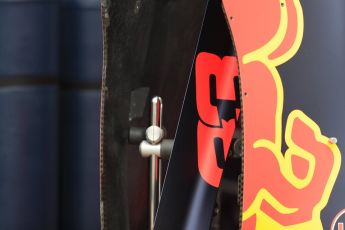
left=0, top=86, right=58, bottom=230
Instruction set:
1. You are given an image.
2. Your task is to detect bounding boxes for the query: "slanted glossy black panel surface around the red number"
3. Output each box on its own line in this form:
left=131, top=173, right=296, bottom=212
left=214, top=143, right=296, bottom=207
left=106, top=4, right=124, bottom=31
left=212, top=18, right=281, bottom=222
left=155, top=0, right=235, bottom=230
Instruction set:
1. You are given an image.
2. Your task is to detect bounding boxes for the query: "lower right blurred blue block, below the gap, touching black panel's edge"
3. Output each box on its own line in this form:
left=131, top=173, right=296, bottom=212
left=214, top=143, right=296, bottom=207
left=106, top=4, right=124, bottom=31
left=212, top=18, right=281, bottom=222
left=60, top=90, right=100, bottom=230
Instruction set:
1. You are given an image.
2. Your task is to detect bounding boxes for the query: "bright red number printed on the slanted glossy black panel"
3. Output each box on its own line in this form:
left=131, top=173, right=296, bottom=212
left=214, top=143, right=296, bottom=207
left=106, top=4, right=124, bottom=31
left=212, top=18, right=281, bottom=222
left=195, top=52, right=240, bottom=187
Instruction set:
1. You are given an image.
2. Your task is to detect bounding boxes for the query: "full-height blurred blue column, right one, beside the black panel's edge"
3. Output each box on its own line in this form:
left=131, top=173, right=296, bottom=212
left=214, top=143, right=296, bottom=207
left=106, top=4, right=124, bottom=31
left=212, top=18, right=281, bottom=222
left=60, top=0, right=102, bottom=230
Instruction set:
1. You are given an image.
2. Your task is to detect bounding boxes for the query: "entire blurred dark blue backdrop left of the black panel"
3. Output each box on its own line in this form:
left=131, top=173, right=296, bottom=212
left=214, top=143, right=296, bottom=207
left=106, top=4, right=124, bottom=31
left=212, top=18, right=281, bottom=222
left=0, top=0, right=102, bottom=230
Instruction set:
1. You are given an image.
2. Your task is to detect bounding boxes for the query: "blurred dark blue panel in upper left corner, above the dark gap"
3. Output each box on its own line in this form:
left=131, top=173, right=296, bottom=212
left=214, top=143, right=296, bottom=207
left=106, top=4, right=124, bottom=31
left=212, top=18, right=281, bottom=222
left=0, top=0, right=58, bottom=79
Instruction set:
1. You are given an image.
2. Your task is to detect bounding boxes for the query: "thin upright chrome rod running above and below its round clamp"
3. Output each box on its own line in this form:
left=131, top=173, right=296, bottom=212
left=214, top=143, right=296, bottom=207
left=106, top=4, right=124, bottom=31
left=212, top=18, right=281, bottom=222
left=149, top=97, right=163, bottom=230
